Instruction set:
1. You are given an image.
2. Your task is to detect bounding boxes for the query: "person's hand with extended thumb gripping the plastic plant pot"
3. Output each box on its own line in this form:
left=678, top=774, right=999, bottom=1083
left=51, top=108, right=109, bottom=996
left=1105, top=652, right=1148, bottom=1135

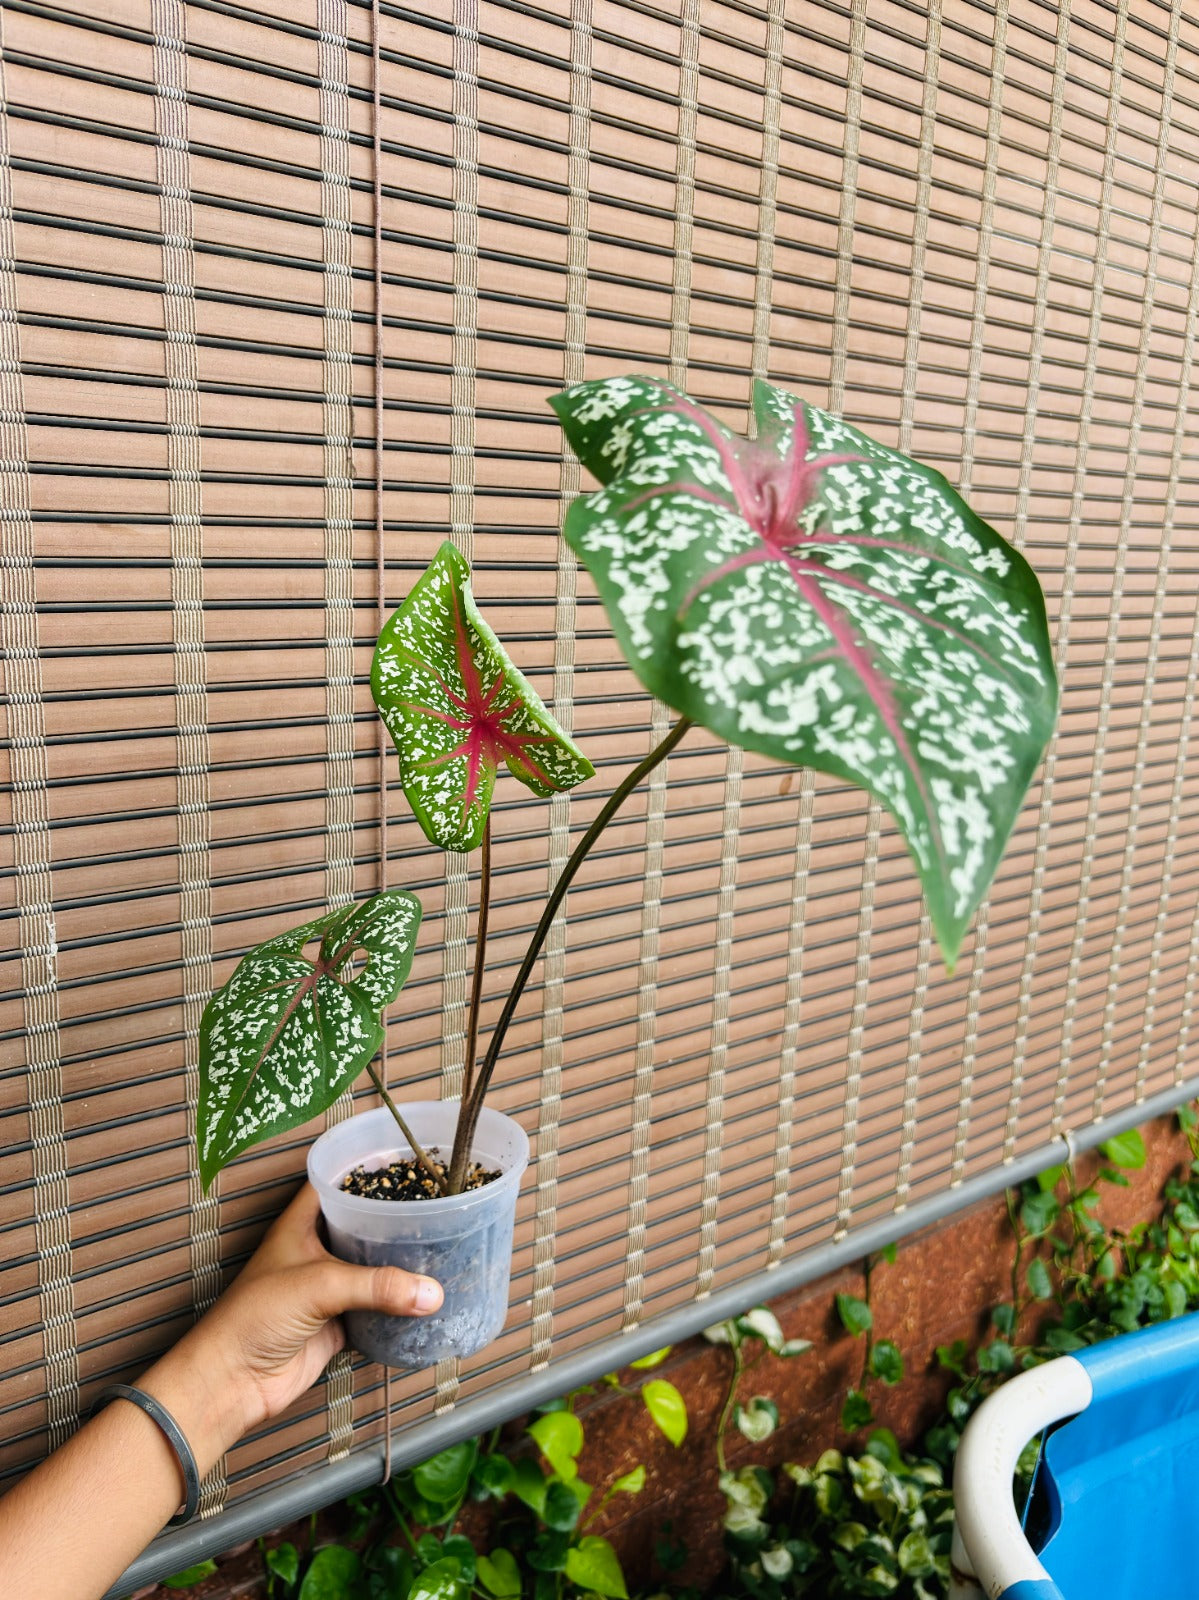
left=139, top=1184, right=442, bottom=1474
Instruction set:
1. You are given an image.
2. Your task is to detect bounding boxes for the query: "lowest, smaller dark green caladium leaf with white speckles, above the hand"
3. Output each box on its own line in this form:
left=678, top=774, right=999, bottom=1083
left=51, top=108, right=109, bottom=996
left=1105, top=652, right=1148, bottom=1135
left=197, top=890, right=421, bottom=1189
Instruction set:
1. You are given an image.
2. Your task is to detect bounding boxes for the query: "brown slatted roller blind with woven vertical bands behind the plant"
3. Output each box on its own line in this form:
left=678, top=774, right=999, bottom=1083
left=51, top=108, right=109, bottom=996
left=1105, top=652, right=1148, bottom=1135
left=0, top=0, right=1199, bottom=1510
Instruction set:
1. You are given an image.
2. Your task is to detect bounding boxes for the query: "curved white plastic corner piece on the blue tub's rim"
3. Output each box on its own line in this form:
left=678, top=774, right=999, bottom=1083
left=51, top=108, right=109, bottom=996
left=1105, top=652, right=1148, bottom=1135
left=949, top=1355, right=1092, bottom=1600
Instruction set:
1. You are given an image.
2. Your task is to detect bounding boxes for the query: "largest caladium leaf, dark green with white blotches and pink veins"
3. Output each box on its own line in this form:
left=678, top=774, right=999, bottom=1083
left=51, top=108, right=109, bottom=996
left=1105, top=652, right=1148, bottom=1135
left=551, top=378, right=1057, bottom=966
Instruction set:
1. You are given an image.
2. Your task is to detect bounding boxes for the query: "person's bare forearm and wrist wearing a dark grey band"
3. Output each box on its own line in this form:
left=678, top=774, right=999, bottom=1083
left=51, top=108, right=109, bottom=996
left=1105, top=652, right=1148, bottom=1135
left=0, top=1339, right=243, bottom=1600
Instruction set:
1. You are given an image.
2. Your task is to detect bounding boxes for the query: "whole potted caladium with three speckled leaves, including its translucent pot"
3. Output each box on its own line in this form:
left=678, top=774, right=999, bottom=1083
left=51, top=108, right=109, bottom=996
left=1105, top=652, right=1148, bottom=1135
left=198, top=378, right=1058, bottom=1365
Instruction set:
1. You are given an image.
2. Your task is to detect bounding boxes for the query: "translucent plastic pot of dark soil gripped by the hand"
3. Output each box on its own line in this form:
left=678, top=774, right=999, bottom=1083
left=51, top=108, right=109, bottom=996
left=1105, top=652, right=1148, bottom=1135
left=307, top=1101, right=528, bottom=1371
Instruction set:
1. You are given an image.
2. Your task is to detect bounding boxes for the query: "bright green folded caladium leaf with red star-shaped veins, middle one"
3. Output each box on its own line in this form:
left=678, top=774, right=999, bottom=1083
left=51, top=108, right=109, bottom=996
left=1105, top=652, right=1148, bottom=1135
left=370, top=544, right=594, bottom=850
